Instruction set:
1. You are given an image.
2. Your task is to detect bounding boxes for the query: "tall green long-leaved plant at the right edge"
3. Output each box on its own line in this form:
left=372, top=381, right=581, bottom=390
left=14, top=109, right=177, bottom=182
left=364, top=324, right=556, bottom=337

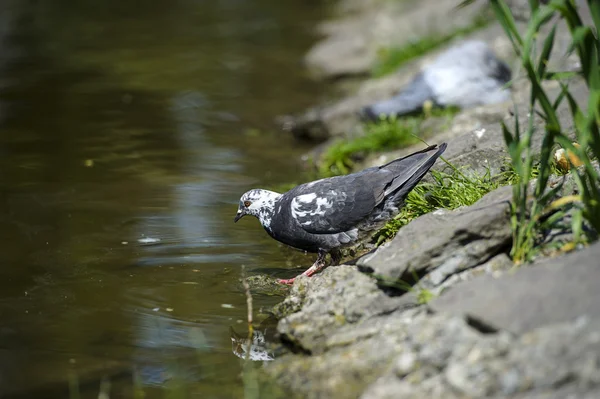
left=478, top=0, right=600, bottom=263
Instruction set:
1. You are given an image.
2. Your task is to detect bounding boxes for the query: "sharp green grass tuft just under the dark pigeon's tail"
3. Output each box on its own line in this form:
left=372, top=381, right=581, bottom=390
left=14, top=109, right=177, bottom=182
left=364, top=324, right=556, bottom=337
left=373, top=164, right=508, bottom=245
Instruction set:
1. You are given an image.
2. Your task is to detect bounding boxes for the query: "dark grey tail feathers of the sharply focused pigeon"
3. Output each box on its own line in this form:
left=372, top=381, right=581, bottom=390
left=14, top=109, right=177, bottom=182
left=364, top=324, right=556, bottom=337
left=381, top=143, right=448, bottom=204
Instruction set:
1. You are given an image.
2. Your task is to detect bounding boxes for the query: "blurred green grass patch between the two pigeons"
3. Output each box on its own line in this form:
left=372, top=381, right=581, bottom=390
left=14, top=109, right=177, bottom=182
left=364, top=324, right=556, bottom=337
left=318, top=107, right=459, bottom=177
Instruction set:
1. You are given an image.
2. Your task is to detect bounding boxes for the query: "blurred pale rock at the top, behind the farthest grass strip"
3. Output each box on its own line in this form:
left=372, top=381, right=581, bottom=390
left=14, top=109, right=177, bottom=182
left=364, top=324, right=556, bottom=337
left=305, top=0, right=488, bottom=79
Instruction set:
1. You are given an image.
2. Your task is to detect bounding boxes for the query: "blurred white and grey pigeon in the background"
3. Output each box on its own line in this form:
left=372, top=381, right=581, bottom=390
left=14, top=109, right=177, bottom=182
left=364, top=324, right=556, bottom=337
left=360, top=40, right=511, bottom=121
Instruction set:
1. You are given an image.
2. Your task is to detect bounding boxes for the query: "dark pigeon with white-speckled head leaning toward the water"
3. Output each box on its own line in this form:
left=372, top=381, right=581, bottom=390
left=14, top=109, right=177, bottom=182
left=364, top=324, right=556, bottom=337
left=234, top=143, right=447, bottom=284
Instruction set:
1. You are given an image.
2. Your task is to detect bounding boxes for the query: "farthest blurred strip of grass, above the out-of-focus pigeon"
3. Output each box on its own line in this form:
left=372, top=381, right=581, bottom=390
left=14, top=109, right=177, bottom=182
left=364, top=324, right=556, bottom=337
left=371, top=16, right=490, bottom=77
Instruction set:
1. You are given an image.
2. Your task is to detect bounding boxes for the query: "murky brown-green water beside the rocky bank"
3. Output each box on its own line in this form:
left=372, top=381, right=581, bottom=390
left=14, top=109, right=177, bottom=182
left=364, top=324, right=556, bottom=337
left=0, top=0, right=323, bottom=398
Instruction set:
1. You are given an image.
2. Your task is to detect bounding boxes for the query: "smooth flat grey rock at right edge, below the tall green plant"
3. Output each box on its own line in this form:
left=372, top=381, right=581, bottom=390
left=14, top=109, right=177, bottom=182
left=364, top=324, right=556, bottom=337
left=430, top=242, right=600, bottom=334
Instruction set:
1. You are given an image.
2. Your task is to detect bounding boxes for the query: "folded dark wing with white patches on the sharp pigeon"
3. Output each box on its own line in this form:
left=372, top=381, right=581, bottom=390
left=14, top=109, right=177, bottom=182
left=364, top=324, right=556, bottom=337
left=285, top=168, right=394, bottom=234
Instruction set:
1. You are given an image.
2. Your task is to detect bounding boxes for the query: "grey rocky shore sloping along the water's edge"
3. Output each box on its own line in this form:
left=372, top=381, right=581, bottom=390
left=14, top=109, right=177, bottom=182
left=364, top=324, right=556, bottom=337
left=253, top=0, right=600, bottom=399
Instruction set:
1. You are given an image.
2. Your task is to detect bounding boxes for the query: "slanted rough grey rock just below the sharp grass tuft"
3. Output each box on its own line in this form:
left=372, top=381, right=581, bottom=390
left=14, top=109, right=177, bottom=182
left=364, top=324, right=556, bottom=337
left=357, top=187, right=512, bottom=286
